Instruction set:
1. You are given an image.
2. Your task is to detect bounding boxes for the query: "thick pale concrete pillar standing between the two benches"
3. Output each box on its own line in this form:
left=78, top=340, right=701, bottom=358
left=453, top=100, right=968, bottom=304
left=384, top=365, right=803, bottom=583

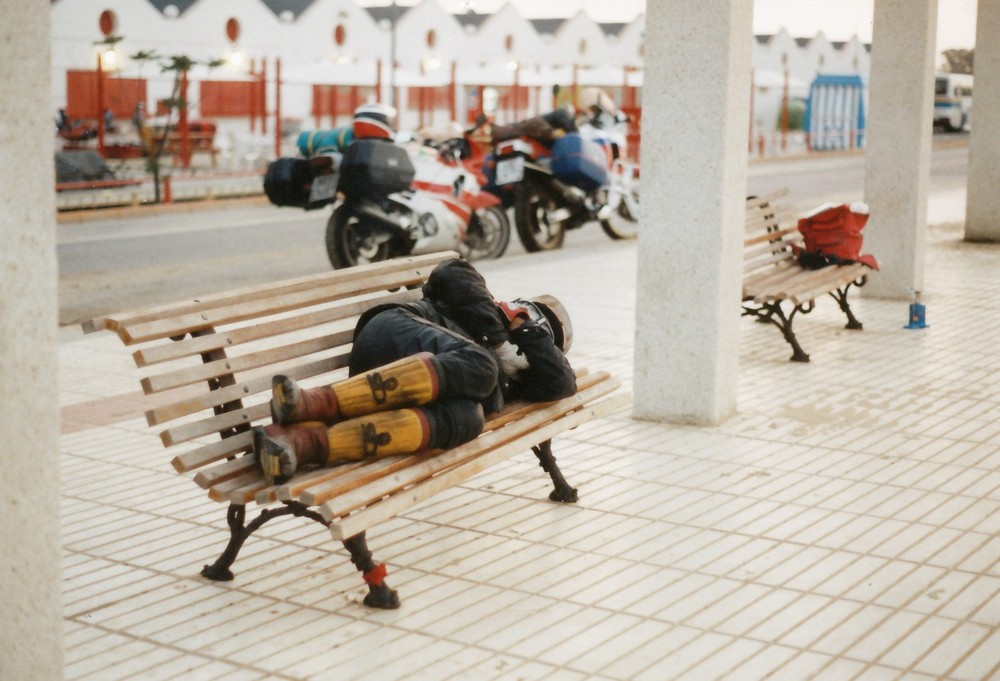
left=633, top=0, right=753, bottom=424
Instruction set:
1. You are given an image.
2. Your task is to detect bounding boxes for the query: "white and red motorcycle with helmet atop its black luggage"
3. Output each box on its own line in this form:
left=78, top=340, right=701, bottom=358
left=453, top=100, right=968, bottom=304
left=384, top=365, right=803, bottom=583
left=264, top=106, right=510, bottom=269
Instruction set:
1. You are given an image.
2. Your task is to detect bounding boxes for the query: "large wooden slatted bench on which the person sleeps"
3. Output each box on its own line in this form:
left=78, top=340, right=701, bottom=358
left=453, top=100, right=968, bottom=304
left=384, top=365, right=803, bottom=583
left=84, top=252, right=628, bottom=608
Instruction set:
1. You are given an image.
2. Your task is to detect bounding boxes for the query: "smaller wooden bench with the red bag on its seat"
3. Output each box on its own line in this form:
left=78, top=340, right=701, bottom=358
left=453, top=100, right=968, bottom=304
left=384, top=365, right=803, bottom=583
left=743, top=190, right=872, bottom=362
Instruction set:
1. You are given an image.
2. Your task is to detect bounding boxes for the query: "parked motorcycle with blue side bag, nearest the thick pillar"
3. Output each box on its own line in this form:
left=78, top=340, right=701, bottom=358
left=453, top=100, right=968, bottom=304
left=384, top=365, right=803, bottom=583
left=487, top=102, right=639, bottom=252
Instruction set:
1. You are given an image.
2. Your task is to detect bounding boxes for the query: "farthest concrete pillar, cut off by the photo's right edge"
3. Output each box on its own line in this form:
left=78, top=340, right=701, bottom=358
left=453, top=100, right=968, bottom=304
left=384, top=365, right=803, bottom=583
left=965, top=0, right=1000, bottom=241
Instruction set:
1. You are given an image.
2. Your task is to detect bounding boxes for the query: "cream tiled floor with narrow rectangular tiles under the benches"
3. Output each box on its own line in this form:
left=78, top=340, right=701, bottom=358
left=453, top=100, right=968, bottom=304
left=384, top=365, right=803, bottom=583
left=60, top=214, right=1000, bottom=681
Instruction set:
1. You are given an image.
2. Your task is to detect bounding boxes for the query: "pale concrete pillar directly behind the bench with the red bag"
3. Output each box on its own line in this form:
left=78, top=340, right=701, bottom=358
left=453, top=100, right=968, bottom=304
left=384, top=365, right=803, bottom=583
left=861, top=0, right=937, bottom=298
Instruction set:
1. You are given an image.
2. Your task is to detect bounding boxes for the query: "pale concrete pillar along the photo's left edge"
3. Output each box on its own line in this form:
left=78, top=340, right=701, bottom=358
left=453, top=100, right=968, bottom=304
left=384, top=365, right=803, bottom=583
left=0, top=0, right=62, bottom=680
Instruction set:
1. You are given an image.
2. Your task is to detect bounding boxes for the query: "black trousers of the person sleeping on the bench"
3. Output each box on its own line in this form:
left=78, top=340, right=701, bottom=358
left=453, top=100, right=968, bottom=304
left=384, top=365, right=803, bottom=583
left=349, top=308, right=498, bottom=449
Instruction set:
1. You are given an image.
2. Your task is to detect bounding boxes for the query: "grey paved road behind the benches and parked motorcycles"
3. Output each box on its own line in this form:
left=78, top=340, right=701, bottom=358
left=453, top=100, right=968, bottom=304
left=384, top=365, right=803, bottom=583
left=58, top=145, right=968, bottom=325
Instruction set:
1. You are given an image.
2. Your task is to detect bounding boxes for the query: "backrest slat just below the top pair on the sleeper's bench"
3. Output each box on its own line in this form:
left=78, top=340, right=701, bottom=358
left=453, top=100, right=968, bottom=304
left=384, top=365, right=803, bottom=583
left=132, top=289, right=421, bottom=368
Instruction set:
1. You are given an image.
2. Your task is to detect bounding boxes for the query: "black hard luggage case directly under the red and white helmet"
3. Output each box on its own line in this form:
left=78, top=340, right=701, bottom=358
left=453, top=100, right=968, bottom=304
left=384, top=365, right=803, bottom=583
left=337, top=139, right=416, bottom=198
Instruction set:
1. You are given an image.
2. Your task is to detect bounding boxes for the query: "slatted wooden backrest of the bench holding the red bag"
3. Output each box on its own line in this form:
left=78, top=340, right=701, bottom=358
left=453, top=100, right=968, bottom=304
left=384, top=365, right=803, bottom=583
left=743, top=190, right=802, bottom=279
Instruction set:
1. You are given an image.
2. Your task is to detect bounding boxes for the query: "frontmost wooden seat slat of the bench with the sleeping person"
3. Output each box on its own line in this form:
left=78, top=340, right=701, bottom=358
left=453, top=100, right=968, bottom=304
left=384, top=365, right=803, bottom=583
left=328, top=395, right=631, bottom=541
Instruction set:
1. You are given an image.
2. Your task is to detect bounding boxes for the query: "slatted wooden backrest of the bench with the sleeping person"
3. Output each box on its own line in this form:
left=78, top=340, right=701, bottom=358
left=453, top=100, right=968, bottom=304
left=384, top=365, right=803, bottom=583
left=92, top=252, right=458, bottom=472
